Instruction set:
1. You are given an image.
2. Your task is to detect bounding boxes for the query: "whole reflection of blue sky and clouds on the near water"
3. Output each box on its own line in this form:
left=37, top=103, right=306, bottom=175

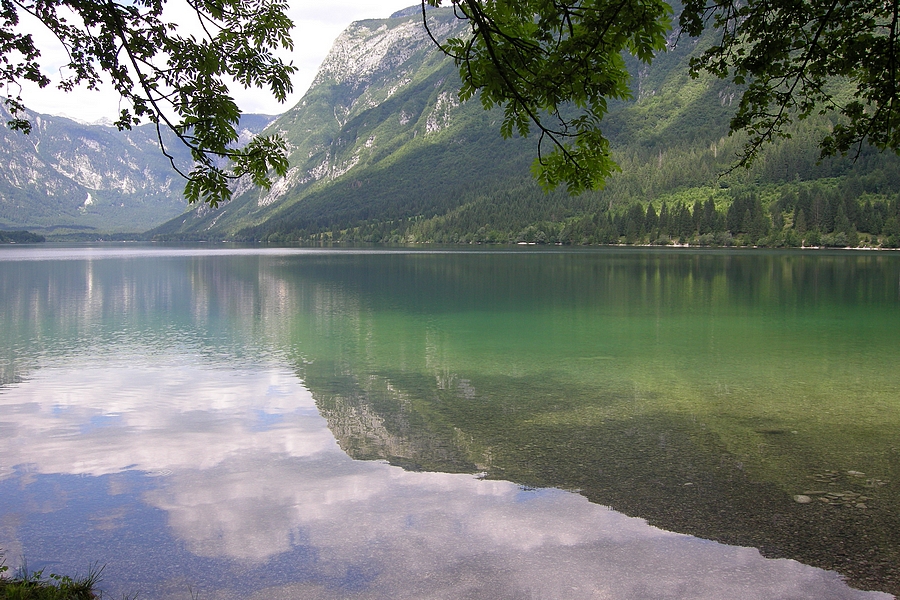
left=0, top=354, right=878, bottom=599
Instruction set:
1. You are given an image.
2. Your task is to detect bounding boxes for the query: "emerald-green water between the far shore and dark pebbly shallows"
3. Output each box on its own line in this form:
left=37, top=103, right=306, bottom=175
left=279, top=246, right=900, bottom=472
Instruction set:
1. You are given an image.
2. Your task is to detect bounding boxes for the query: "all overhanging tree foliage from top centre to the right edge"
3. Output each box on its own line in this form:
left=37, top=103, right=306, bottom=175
left=422, top=0, right=900, bottom=192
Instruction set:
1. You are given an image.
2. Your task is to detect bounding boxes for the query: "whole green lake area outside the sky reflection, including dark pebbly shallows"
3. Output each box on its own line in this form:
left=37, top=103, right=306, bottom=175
left=272, top=250, right=900, bottom=593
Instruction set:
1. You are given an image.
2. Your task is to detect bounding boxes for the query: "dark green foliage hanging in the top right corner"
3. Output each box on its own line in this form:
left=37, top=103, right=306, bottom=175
left=681, top=0, right=900, bottom=162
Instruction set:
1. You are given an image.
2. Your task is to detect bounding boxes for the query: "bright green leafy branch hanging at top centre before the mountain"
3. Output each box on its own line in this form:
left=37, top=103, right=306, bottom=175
left=421, top=0, right=671, bottom=193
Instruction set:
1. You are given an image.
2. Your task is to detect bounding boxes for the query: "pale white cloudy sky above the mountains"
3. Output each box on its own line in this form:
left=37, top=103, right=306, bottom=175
left=8, top=0, right=416, bottom=123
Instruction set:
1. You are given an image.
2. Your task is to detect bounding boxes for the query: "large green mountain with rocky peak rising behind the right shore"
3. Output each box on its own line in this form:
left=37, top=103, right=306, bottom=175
left=150, top=9, right=900, bottom=245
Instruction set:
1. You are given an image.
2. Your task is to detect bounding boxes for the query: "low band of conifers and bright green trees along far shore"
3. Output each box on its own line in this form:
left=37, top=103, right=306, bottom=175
left=362, top=183, right=900, bottom=248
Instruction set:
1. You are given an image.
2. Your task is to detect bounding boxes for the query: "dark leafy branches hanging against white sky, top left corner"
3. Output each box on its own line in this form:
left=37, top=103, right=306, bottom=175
left=0, top=0, right=295, bottom=206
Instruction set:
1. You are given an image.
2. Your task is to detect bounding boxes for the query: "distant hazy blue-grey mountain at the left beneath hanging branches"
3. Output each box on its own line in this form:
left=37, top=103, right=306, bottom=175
left=0, top=107, right=273, bottom=234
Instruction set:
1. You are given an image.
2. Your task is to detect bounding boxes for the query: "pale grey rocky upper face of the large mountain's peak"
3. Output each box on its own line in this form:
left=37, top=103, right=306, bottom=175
left=270, top=14, right=458, bottom=192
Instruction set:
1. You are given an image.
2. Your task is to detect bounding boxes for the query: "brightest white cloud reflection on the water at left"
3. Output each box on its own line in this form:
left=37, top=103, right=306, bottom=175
left=0, top=356, right=337, bottom=477
